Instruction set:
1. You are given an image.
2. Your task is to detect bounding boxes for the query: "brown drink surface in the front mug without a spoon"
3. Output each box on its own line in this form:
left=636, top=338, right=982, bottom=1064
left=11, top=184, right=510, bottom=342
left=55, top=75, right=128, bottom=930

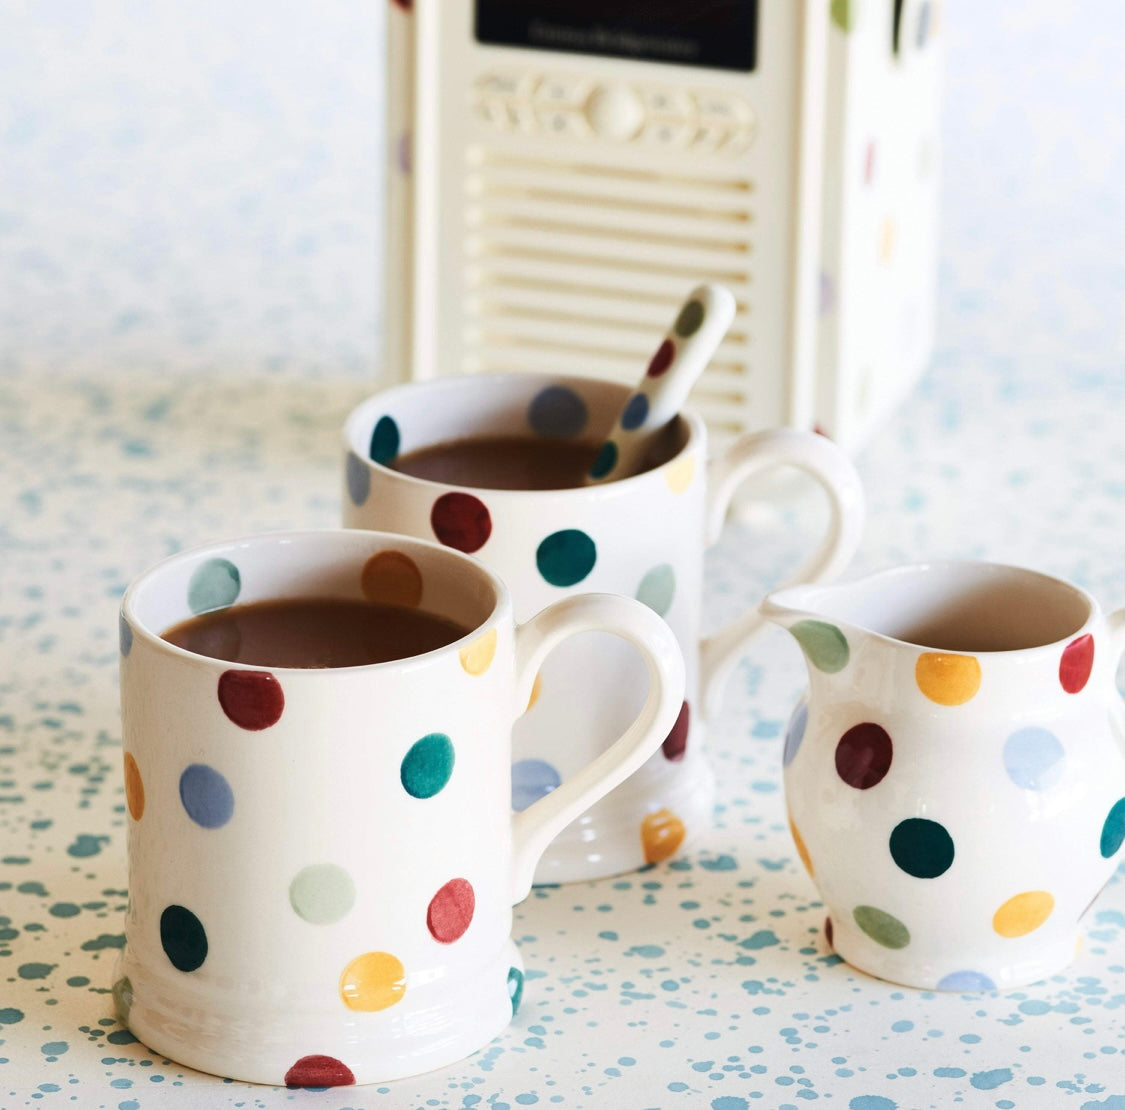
left=163, top=597, right=469, bottom=667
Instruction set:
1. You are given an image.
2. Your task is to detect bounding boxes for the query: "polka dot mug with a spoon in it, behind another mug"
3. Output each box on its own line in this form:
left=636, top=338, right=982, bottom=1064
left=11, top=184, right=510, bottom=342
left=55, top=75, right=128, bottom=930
left=343, top=373, right=863, bottom=883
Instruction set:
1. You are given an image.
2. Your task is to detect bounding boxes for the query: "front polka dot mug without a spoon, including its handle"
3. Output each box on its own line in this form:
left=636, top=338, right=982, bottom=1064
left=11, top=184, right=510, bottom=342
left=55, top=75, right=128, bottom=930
left=114, top=531, right=684, bottom=1086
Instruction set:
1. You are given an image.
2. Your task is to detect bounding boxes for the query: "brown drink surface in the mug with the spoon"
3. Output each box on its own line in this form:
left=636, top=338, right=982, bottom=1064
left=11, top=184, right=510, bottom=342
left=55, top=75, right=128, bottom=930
left=390, top=435, right=600, bottom=489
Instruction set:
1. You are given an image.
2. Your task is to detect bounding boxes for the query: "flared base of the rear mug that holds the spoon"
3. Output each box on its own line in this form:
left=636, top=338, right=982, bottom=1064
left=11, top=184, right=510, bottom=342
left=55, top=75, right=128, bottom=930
left=534, top=755, right=714, bottom=886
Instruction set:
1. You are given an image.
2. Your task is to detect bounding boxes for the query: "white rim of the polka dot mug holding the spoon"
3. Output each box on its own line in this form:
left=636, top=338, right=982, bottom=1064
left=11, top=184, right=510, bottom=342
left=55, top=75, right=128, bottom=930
left=342, top=370, right=707, bottom=500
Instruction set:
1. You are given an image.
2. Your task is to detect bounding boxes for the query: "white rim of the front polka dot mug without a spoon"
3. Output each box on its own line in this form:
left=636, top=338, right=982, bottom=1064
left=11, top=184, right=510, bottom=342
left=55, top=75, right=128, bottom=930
left=118, top=529, right=515, bottom=676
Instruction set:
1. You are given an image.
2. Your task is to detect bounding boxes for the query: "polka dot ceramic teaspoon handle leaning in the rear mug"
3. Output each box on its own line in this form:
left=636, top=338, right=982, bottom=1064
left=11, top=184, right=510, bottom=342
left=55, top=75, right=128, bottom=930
left=586, top=285, right=735, bottom=485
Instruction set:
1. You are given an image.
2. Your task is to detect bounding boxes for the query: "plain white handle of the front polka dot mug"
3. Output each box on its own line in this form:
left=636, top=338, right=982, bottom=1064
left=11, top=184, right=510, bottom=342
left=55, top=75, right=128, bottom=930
left=512, top=594, right=685, bottom=905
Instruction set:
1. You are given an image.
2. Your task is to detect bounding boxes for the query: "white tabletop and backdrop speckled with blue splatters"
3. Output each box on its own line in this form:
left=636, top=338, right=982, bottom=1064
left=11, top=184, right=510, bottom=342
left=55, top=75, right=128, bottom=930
left=0, top=0, right=1125, bottom=1110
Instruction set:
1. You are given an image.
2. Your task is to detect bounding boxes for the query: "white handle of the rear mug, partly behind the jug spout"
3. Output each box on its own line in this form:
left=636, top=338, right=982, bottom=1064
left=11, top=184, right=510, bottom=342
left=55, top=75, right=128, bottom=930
left=700, top=427, right=865, bottom=716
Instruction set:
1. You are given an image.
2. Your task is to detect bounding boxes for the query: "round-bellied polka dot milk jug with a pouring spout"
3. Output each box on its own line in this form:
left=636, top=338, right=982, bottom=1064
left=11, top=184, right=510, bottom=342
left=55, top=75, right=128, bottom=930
left=763, top=562, right=1125, bottom=991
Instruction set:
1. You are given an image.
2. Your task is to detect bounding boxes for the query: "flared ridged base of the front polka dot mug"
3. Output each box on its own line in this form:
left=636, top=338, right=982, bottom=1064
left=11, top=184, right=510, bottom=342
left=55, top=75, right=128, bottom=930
left=114, top=940, right=523, bottom=1088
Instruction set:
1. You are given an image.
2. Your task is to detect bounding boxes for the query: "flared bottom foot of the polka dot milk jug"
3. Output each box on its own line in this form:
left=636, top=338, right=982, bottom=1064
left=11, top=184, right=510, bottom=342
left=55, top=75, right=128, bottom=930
left=826, top=920, right=1082, bottom=994
